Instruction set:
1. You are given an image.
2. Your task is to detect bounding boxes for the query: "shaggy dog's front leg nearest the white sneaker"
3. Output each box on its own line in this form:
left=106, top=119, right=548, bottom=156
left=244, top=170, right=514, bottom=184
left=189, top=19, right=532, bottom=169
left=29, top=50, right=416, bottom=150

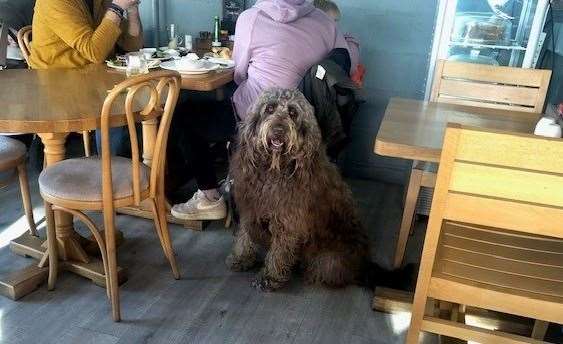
left=225, top=218, right=258, bottom=272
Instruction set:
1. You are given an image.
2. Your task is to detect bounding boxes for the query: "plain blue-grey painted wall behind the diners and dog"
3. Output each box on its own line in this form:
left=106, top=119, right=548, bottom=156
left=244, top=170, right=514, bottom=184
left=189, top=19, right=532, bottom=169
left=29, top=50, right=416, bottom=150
left=142, top=0, right=437, bottom=182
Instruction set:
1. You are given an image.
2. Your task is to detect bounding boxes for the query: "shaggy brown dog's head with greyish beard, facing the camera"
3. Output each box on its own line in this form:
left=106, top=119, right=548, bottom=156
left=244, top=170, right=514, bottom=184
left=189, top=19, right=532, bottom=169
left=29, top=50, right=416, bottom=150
left=241, top=88, right=321, bottom=169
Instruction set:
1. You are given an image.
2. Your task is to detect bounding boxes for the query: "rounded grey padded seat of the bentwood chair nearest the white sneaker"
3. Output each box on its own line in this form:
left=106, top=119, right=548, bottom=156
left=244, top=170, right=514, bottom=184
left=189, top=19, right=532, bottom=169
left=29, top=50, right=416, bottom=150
left=39, top=156, right=150, bottom=203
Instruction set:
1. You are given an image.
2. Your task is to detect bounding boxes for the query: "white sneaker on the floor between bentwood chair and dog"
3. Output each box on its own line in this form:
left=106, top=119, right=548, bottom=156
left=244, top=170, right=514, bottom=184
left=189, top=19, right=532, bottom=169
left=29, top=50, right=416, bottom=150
left=171, top=190, right=227, bottom=221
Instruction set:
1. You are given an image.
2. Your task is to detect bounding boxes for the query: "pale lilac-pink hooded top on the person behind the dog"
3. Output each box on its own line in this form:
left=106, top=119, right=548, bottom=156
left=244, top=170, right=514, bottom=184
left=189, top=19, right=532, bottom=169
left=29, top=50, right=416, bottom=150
left=233, top=0, right=348, bottom=119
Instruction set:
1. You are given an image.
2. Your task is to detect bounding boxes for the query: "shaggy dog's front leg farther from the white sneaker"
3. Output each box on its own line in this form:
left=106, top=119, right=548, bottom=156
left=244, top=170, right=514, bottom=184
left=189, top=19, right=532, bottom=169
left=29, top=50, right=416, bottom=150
left=253, top=229, right=299, bottom=291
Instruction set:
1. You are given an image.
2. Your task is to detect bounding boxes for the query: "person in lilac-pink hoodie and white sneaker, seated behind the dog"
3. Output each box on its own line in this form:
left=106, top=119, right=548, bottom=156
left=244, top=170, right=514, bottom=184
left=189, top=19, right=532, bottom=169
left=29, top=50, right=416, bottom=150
left=172, top=0, right=348, bottom=220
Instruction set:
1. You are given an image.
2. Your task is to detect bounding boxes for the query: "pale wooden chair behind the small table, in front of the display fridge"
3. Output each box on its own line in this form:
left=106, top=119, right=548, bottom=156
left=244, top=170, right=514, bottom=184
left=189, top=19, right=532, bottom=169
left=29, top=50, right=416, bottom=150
left=394, top=60, right=551, bottom=268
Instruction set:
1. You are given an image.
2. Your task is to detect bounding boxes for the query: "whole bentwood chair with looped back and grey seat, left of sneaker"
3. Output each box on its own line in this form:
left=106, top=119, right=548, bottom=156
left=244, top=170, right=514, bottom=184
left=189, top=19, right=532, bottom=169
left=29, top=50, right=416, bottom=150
left=39, top=71, right=180, bottom=321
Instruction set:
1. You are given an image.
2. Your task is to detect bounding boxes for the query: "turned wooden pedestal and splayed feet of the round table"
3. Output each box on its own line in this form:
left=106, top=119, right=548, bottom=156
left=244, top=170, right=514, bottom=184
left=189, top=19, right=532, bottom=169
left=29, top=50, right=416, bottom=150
left=0, top=133, right=125, bottom=300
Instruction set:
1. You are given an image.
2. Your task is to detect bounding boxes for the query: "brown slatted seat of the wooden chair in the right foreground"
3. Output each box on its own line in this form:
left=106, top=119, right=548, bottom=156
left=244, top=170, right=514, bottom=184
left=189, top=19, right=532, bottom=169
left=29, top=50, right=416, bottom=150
left=429, top=221, right=563, bottom=321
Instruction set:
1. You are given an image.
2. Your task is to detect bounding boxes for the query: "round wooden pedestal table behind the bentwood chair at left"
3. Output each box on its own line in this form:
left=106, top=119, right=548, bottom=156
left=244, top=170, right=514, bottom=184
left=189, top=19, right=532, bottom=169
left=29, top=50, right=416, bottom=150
left=0, top=65, right=145, bottom=299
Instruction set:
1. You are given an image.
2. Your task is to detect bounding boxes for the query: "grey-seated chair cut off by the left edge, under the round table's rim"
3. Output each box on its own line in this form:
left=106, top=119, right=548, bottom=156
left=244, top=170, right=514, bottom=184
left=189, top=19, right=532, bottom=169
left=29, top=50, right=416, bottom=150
left=0, top=135, right=37, bottom=236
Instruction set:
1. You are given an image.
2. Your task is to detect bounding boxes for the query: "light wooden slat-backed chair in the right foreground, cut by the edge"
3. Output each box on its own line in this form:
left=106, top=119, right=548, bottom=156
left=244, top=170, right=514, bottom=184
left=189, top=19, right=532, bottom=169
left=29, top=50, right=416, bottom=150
left=407, top=124, right=563, bottom=344
